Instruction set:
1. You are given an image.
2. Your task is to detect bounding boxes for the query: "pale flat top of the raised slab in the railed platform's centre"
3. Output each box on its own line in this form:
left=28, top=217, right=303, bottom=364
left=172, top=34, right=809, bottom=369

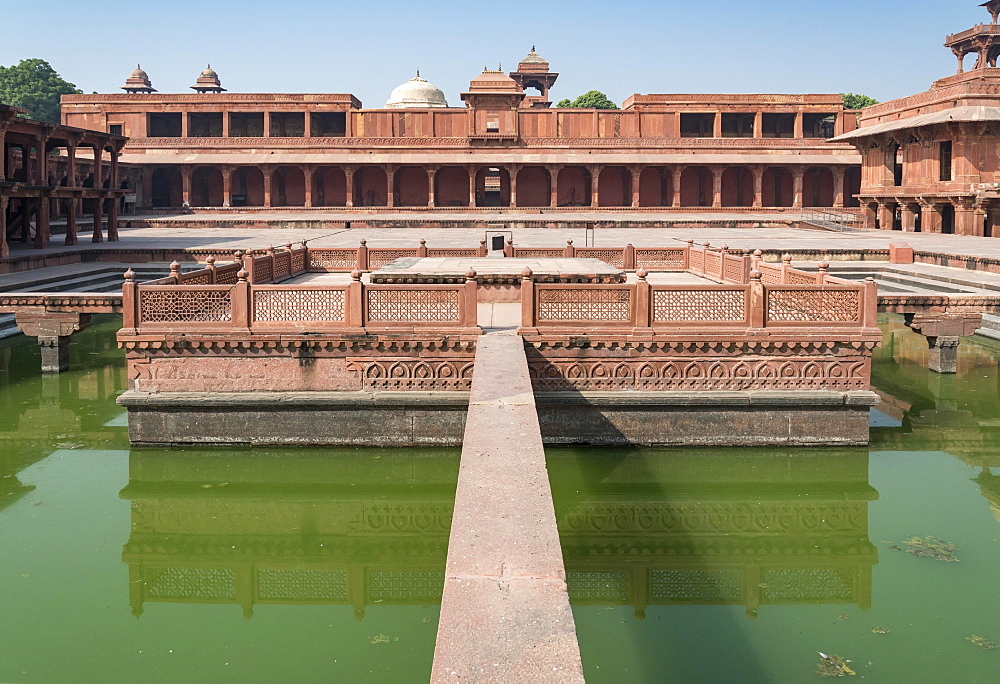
left=371, top=257, right=625, bottom=283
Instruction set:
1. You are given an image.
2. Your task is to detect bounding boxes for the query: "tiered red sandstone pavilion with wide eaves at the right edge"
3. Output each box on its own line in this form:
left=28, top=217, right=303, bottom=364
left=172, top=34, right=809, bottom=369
left=834, top=0, right=1000, bottom=237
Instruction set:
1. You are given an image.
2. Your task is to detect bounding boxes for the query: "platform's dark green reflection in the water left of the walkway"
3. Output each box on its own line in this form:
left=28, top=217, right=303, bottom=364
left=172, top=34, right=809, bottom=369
left=121, top=449, right=458, bottom=619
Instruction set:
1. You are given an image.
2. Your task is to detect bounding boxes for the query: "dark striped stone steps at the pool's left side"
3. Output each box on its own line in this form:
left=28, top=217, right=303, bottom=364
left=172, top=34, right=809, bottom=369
left=0, top=263, right=182, bottom=339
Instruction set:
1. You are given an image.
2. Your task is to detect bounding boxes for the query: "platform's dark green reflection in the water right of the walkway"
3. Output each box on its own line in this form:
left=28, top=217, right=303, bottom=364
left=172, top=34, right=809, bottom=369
left=549, top=449, right=878, bottom=618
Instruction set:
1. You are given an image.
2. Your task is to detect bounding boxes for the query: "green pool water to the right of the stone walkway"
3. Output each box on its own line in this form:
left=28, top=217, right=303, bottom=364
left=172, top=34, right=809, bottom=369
left=548, top=319, right=1000, bottom=683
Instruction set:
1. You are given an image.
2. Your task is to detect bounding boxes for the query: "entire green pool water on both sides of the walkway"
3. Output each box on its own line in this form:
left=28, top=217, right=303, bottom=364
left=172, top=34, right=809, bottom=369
left=0, top=319, right=1000, bottom=682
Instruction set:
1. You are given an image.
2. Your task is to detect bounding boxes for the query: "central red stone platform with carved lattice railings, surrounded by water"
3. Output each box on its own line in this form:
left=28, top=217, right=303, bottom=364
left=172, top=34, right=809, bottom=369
left=119, top=242, right=881, bottom=445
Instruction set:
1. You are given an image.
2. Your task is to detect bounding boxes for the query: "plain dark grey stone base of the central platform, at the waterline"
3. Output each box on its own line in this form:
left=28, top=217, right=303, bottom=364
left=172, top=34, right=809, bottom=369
left=118, top=391, right=878, bottom=447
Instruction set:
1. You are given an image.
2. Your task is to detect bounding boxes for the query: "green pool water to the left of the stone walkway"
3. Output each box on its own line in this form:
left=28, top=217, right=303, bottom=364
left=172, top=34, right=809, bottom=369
left=0, top=319, right=460, bottom=682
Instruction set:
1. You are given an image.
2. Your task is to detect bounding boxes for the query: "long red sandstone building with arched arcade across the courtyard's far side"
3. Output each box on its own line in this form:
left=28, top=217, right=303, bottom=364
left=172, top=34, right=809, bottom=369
left=62, top=49, right=861, bottom=211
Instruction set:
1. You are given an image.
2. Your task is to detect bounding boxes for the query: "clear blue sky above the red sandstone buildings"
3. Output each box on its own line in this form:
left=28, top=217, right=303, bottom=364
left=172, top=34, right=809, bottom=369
left=0, top=0, right=989, bottom=107
